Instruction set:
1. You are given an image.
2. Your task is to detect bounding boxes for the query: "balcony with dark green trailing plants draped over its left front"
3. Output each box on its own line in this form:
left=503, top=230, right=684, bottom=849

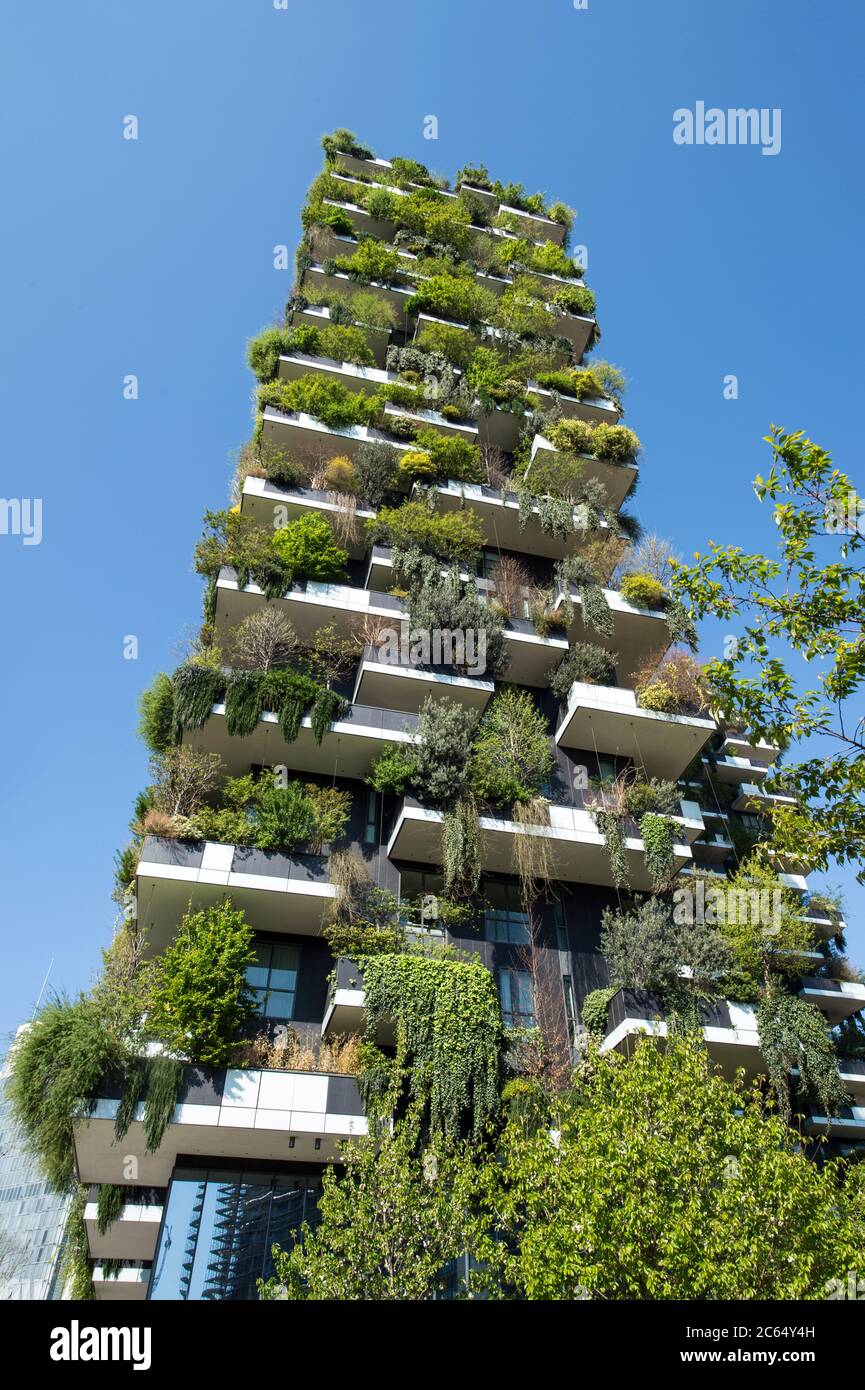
left=184, top=705, right=417, bottom=778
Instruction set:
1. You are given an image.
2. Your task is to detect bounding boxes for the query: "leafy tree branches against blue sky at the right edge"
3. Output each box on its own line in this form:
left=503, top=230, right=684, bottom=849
left=674, top=427, right=865, bottom=881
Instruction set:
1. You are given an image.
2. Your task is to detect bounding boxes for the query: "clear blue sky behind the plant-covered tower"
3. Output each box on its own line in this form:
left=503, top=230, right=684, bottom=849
left=0, top=0, right=865, bottom=1036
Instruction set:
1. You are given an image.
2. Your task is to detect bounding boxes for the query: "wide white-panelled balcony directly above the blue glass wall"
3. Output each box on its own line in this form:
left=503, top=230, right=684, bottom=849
left=74, top=1066, right=367, bottom=1187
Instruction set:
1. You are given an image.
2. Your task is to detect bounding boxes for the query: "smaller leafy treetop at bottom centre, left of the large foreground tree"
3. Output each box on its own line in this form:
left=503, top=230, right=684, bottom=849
left=259, top=1126, right=474, bottom=1302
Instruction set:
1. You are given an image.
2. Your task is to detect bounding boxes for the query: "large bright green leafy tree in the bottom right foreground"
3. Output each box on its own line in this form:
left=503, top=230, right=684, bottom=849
left=474, top=1037, right=865, bottom=1300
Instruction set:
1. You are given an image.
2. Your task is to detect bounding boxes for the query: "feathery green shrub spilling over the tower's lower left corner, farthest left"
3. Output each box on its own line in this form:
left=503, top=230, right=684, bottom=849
left=7, top=995, right=121, bottom=1193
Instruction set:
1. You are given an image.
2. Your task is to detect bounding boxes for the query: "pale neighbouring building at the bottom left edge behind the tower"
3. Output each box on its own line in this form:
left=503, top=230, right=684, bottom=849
left=0, top=1024, right=68, bottom=1301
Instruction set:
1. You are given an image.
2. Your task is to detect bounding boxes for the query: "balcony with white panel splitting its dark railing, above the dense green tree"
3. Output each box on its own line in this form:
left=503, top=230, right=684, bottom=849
left=136, top=835, right=337, bottom=950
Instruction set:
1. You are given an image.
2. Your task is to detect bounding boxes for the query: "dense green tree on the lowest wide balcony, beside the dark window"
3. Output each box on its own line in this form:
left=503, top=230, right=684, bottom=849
left=149, top=901, right=254, bottom=1061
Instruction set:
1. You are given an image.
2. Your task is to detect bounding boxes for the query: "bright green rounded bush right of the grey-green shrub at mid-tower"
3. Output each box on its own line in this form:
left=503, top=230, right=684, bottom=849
left=470, top=689, right=553, bottom=806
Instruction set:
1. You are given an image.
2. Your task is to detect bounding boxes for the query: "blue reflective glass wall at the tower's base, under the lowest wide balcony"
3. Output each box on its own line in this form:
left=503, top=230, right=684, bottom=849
left=149, top=1166, right=321, bottom=1300
